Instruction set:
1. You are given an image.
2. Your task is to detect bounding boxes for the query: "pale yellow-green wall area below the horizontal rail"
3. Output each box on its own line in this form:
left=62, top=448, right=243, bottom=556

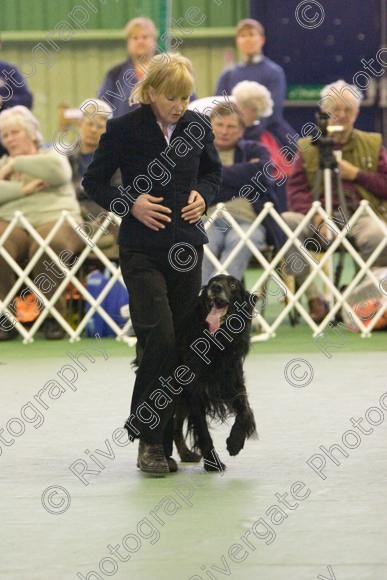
left=2, top=39, right=239, bottom=141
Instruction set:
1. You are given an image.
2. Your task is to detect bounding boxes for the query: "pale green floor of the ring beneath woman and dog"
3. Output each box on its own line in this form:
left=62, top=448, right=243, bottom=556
left=0, top=346, right=387, bottom=580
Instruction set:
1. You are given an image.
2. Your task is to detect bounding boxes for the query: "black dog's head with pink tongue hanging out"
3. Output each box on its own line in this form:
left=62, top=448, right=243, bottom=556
left=201, top=274, right=257, bottom=332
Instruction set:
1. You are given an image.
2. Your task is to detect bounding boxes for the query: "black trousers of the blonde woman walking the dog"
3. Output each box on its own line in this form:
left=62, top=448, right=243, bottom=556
left=120, top=246, right=203, bottom=456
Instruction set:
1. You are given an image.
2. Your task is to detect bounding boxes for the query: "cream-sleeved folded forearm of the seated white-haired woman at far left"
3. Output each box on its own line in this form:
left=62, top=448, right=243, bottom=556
left=14, top=150, right=72, bottom=187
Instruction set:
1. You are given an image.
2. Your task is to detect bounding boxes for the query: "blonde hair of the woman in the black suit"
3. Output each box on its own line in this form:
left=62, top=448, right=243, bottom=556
left=129, top=52, right=195, bottom=105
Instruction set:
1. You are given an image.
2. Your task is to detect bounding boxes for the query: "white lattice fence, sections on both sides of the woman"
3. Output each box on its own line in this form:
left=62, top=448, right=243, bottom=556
left=0, top=201, right=387, bottom=345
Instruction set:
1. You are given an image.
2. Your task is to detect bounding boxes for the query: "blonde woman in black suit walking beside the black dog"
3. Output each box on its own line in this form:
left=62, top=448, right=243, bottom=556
left=83, top=53, right=221, bottom=473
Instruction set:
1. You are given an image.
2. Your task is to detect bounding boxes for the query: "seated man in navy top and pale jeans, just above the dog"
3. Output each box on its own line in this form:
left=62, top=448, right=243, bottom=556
left=202, top=104, right=283, bottom=284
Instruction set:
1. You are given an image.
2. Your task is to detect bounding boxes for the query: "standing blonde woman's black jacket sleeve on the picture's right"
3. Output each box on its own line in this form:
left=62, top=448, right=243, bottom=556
left=195, top=131, right=222, bottom=211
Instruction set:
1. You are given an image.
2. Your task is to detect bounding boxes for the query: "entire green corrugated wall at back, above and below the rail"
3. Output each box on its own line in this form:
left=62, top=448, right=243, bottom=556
left=0, top=0, right=247, bottom=141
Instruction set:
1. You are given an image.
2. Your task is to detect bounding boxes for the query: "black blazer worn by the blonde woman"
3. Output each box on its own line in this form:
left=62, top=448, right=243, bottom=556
left=82, top=105, right=221, bottom=249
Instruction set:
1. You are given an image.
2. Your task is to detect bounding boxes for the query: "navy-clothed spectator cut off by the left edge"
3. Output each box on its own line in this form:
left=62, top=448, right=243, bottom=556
left=0, top=40, right=32, bottom=157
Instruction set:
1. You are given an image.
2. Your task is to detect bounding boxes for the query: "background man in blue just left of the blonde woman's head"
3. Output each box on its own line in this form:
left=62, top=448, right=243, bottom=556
left=98, top=17, right=157, bottom=117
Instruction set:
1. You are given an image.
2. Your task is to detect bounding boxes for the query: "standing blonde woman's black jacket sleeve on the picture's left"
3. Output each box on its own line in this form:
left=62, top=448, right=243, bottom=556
left=82, top=120, right=123, bottom=211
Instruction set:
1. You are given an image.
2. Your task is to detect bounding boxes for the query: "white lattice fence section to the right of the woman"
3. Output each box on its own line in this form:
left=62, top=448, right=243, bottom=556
left=204, top=200, right=387, bottom=340
